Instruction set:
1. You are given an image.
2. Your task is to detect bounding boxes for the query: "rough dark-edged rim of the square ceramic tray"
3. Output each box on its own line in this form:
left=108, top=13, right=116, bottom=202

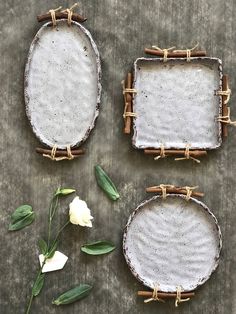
left=132, top=57, right=223, bottom=151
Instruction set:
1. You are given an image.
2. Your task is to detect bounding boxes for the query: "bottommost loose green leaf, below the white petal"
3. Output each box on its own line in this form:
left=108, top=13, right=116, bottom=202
left=52, top=284, right=93, bottom=305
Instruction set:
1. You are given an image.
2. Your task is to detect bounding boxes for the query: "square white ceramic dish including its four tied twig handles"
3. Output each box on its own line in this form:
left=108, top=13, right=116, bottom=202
left=123, top=49, right=232, bottom=161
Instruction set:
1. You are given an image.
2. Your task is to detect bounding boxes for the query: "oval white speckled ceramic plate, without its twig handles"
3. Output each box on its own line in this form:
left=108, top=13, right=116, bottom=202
left=25, top=20, right=101, bottom=149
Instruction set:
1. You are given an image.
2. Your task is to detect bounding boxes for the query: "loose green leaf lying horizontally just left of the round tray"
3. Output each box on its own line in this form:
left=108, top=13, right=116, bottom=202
left=81, top=241, right=116, bottom=255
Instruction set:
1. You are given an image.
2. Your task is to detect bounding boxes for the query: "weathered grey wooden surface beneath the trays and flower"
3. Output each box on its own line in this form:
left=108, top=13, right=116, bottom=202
left=0, top=0, right=236, bottom=314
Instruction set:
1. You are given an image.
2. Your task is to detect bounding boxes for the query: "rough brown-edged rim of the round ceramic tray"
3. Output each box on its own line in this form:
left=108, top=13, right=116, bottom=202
left=122, top=193, right=222, bottom=293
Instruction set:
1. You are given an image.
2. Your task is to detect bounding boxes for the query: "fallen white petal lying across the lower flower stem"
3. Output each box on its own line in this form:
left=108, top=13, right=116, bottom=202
left=39, top=251, right=68, bottom=273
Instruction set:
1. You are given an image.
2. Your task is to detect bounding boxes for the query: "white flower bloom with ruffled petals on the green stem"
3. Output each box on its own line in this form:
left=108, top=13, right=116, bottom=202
left=69, top=196, right=93, bottom=227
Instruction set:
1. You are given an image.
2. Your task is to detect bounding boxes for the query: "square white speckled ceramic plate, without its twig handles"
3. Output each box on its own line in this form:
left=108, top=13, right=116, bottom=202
left=133, top=58, right=222, bottom=149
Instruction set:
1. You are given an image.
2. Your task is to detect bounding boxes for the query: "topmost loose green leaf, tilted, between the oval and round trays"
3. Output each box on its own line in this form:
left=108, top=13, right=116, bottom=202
left=95, top=165, right=120, bottom=201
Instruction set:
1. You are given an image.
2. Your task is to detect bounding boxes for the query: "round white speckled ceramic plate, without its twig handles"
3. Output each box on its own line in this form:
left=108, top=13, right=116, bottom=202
left=124, top=195, right=221, bottom=292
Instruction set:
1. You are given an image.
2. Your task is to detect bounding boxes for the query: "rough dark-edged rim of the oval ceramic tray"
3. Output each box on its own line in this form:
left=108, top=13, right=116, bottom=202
left=23, top=19, right=102, bottom=149
